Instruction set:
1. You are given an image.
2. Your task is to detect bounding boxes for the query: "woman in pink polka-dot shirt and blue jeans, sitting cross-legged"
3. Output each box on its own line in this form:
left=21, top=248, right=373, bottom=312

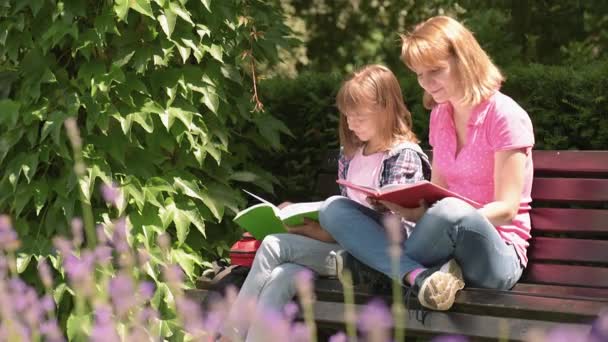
left=320, top=16, right=534, bottom=310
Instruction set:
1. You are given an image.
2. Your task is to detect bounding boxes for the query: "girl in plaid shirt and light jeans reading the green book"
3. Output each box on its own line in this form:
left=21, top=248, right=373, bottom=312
left=224, top=65, right=430, bottom=340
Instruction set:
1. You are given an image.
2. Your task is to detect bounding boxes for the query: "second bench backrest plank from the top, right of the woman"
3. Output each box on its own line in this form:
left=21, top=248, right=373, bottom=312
left=532, top=177, right=608, bottom=205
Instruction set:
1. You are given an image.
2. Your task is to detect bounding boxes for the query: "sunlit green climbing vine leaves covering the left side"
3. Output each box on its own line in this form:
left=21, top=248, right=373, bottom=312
left=0, top=0, right=293, bottom=332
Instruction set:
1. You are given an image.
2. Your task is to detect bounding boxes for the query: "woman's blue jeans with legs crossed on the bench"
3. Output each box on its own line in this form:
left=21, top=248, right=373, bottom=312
left=319, top=196, right=523, bottom=289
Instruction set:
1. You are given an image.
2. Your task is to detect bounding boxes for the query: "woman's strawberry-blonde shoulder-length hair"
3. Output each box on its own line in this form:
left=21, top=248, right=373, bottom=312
left=401, top=16, right=504, bottom=109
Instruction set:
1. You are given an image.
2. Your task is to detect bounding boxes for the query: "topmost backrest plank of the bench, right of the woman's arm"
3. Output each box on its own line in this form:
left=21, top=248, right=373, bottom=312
left=532, top=150, right=608, bottom=173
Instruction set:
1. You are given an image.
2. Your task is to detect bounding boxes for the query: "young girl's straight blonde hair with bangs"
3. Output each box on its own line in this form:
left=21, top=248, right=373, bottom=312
left=336, top=64, right=418, bottom=156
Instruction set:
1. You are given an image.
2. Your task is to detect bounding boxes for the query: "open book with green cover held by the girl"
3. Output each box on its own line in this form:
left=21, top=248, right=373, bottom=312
left=234, top=190, right=323, bottom=240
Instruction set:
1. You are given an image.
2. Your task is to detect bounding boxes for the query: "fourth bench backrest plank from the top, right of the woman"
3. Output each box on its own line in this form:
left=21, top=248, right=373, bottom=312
left=528, top=237, right=608, bottom=265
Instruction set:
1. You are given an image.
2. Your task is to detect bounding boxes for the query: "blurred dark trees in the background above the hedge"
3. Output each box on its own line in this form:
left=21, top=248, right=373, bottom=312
left=283, top=0, right=608, bottom=72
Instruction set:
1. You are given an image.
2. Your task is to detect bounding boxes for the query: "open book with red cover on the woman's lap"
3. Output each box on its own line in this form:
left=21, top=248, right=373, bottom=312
left=337, top=179, right=482, bottom=208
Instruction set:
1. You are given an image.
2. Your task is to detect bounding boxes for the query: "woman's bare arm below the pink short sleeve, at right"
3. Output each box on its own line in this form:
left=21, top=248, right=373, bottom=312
left=479, top=149, right=526, bottom=226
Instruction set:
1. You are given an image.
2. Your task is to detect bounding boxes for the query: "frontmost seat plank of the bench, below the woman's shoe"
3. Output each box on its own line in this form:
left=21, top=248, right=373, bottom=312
left=314, top=302, right=590, bottom=341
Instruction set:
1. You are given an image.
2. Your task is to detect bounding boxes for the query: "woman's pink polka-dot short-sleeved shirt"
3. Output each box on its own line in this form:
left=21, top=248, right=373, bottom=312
left=429, top=92, right=534, bottom=266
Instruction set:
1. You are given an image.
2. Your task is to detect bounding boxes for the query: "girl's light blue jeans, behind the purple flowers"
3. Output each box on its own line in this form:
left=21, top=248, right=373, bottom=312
left=223, top=234, right=341, bottom=341
